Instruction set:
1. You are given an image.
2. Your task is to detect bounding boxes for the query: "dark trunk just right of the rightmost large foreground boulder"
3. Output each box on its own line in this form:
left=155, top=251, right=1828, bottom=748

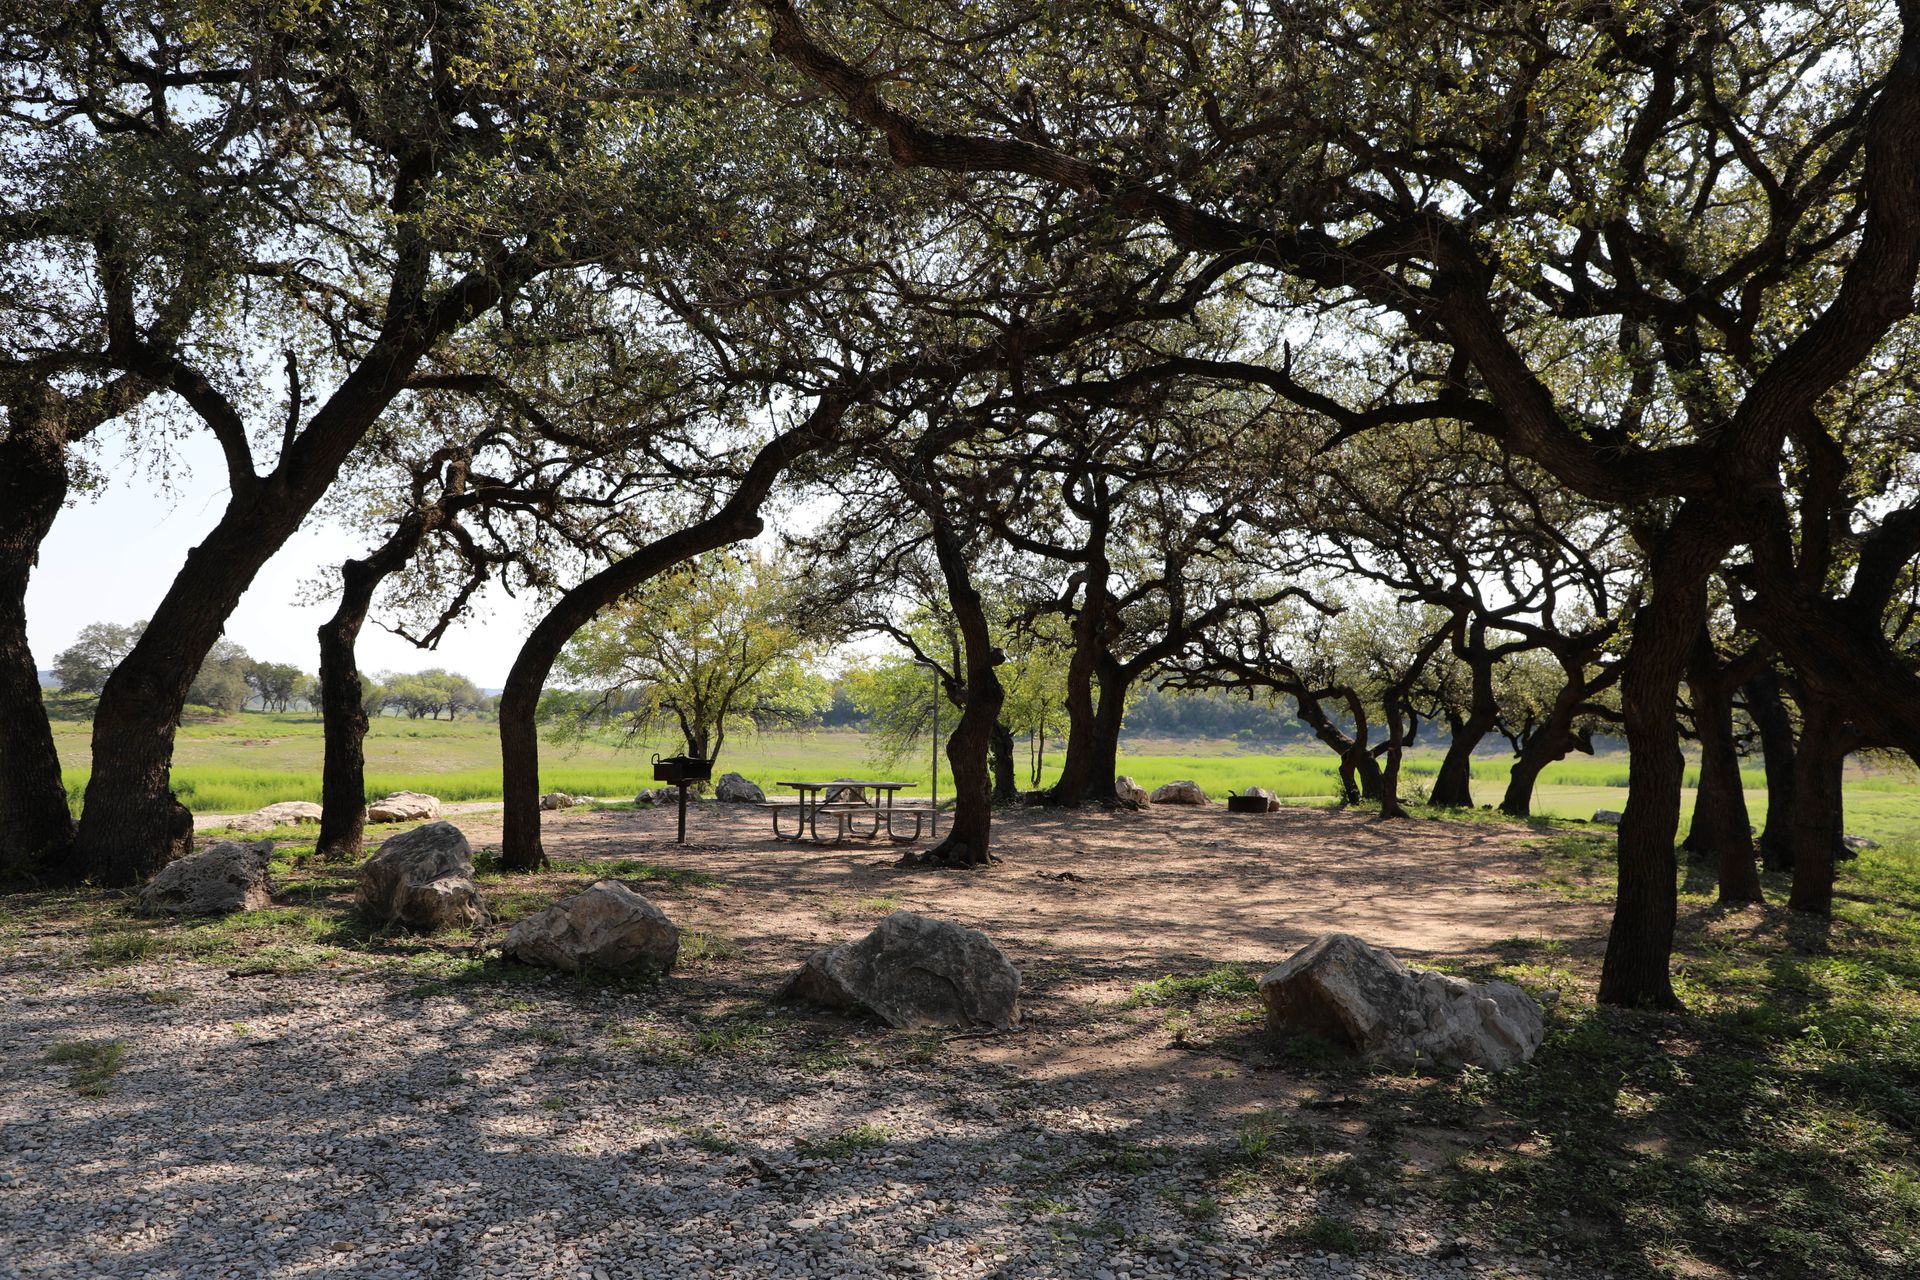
left=1599, top=556, right=1716, bottom=1009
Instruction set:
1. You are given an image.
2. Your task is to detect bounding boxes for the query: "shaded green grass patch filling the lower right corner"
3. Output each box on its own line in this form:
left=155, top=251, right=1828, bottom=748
left=1415, top=835, right=1920, bottom=1280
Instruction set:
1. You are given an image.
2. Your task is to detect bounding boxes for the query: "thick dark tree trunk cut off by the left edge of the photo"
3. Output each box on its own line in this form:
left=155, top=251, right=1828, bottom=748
left=0, top=420, right=73, bottom=873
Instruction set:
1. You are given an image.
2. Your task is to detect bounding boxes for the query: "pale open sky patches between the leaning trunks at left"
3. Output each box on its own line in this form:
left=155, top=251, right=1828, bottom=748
left=27, top=432, right=534, bottom=689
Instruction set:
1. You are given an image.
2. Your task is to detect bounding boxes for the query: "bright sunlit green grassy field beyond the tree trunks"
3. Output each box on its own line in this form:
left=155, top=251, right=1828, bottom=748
left=37, top=712, right=1920, bottom=841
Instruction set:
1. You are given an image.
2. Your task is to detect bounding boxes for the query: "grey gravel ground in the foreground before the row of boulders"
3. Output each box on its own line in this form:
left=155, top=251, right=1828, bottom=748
left=0, top=967, right=1605, bottom=1280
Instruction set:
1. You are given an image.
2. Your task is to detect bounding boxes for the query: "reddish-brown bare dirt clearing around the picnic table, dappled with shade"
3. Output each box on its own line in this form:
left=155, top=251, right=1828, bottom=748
left=449, top=802, right=1607, bottom=1115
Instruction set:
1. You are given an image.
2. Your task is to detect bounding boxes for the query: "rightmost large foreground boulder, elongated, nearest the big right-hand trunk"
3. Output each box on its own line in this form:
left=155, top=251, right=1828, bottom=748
left=1260, top=933, right=1546, bottom=1071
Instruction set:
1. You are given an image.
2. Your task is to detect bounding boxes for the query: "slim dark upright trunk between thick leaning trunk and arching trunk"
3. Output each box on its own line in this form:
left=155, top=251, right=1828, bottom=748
left=315, top=512, right=430, bottom=862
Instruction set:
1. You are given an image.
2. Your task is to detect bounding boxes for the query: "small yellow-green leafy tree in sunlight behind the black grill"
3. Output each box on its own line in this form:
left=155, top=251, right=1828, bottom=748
left=545, top=553, right=831, bottom=760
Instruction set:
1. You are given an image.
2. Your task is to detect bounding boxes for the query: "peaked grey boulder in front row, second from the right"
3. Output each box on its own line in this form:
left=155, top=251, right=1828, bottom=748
left=781, top=912, right=1020, bottom=1029
